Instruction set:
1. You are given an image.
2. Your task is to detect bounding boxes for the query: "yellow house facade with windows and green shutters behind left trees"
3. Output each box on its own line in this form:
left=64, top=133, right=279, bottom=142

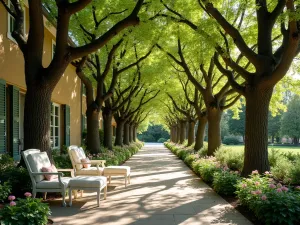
left=0, top=1, right=113, bottom=160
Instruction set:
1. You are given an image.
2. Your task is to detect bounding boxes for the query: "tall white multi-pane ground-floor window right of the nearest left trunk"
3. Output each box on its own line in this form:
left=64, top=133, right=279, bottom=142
left=50, top=103, right=60, bottom=149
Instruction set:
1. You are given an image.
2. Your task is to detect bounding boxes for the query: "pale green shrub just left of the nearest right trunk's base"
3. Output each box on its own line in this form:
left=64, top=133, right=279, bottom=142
left=215, top=147, right=244, bottom=171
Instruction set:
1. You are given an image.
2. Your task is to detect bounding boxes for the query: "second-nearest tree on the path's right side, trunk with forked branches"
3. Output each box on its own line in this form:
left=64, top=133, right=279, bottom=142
left=158, top=38, right=240, bottom=155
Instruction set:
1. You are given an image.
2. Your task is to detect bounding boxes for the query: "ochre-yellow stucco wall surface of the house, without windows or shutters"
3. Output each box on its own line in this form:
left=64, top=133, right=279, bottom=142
left=0, top=4, right=81, bottom=145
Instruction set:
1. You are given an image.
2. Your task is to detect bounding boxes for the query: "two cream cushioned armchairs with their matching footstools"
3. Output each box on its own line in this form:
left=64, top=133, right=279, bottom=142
left=22, top=145, right=130, bottom=206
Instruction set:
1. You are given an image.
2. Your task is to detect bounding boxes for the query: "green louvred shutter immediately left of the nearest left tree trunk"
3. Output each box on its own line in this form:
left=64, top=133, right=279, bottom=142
left=9, top=86, right=21, bottom=161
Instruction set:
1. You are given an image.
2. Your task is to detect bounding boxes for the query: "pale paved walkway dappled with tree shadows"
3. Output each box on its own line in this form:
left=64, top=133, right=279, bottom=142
left=50, top=144, right=251, bottom=225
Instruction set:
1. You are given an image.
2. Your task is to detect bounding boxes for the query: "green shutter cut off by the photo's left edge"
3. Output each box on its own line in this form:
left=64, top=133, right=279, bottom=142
left=0, top=79, right=7, bottom=154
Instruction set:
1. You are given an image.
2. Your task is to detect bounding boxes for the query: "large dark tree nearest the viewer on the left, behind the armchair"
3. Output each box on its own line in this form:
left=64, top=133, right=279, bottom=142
left=0, top=0, right=144, bottom=157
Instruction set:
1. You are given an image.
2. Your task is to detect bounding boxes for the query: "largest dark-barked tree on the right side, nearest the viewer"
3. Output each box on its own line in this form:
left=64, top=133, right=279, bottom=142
left=202, top=0, right=300, bottom=176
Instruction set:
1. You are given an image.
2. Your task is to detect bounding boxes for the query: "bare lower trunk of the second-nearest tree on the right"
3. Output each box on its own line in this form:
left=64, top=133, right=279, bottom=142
left=207, top=107, right=223, bottom=156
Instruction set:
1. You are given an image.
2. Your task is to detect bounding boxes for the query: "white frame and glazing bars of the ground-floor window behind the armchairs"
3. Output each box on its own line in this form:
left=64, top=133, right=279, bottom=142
left=50, top=103, right=61, bottom=149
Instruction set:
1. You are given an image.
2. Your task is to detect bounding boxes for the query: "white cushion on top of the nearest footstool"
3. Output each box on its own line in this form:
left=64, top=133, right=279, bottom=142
left=69, top=176, right=107, bottom=188
